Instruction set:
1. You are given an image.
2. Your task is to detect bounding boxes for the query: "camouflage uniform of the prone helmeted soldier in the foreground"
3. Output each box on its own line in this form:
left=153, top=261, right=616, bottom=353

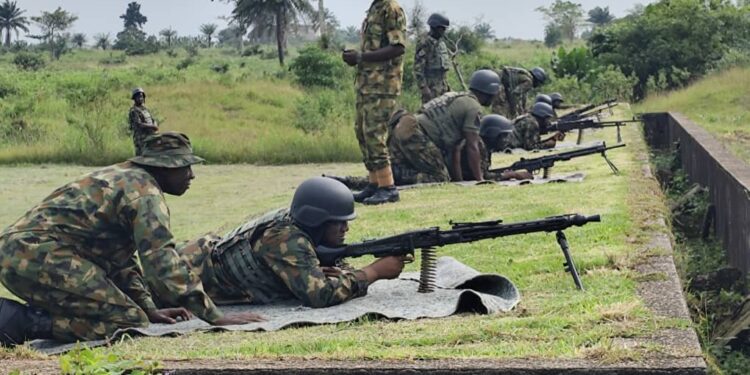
left=173, top=209, right=368, bottom=307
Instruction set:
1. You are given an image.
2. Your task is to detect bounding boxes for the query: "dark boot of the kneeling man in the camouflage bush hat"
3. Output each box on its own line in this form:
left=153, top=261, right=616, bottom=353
left=0, top=298, right=52, bottom=347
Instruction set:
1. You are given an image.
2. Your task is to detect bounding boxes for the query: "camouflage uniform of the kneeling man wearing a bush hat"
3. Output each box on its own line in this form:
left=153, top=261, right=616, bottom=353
left=0, top=137, right=222, bottom=341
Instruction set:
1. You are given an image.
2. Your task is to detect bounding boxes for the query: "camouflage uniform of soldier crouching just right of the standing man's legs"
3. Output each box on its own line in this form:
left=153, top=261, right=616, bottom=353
left=388, top=92, right=482, bottom=185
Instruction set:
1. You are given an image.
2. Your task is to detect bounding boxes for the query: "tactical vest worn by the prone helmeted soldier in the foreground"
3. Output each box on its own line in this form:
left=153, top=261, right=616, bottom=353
left=212, top=208, right=289, bottom=304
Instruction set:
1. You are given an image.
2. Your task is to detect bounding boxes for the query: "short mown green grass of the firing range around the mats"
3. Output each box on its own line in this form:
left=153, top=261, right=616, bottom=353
left=0, top=111, right=691, bottom=363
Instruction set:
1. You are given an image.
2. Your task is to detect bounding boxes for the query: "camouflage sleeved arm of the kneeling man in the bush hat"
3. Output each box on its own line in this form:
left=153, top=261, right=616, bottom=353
left=124, top=194, right=223, bottom=323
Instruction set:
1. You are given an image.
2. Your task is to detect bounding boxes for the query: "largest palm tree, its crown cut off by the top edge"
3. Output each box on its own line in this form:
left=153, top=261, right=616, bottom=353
left=232, top=0, right=315, bottom=66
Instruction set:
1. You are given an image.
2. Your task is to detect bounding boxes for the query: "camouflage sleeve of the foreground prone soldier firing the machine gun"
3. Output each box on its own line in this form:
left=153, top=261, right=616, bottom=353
left=257, top=233, right=368, bottom=307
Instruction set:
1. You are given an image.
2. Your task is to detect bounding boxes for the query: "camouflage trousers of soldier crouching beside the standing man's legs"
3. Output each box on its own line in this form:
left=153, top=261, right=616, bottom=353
left=388, top=114, right=451, bottom=185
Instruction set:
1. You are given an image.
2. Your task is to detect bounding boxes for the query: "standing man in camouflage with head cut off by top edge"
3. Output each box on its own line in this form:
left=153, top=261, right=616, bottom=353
left=342, top=0, right=406, bottom=204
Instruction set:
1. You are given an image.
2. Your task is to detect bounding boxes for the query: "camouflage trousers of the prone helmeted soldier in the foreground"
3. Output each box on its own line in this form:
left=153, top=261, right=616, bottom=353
left=170, top=234, right=253, bottom=307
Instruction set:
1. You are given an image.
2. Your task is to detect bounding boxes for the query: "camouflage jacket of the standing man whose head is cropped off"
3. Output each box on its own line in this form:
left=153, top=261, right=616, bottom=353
left=357, top=0, right=406, bottom=95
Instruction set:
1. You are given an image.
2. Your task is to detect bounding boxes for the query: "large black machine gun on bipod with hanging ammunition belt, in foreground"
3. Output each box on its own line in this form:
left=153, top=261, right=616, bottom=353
left=315, top=214, right=601, bottom=293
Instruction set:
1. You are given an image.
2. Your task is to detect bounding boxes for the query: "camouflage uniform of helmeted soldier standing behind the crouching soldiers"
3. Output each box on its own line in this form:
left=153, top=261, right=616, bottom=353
left=414, top=34, right=450, bottom=103
